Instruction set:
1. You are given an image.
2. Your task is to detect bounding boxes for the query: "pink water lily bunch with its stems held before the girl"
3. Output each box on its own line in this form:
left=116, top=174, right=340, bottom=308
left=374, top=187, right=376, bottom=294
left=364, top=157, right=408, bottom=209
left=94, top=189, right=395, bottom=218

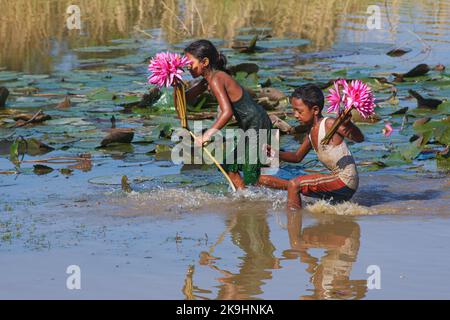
left=148, top=52, right=190, bottom=128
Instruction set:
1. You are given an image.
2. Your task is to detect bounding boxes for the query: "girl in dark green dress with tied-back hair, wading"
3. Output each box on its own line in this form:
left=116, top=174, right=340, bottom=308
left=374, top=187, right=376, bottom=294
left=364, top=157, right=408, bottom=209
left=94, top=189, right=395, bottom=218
left=184, top=40, right=272, bottom=189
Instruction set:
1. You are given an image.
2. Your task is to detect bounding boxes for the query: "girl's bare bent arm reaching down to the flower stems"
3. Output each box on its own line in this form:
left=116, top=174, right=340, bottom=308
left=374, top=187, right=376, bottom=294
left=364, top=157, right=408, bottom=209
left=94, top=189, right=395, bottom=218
left=198, top=78, right=233, bottom=144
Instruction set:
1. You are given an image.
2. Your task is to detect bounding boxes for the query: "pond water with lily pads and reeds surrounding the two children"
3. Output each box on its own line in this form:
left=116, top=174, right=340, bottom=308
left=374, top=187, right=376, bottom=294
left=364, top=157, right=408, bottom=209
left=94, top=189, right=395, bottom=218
left=0, top=0, right=450, bottom=299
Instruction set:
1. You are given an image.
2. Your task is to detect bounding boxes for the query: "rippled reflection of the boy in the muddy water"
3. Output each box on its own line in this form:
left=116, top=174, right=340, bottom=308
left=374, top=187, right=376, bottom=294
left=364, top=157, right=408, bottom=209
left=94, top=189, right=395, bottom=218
left=283, top=211, right=367, bottom=300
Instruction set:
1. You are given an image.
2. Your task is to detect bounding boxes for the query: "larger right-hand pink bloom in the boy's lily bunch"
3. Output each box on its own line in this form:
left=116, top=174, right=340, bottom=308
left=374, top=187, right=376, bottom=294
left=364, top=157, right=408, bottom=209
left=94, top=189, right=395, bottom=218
left=343, top=80, right=375, bottom=118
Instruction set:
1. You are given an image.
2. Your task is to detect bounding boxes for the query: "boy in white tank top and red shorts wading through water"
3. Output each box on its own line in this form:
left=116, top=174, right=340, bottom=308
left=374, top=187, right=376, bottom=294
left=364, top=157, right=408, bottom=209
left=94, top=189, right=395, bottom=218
left=260, top=84, right=364, bottom=209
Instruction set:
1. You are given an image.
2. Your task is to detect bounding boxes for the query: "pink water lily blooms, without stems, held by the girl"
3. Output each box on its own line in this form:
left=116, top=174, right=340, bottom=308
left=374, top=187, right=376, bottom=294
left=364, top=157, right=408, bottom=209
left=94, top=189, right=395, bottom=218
left=148, top=52, right=190, bottom=87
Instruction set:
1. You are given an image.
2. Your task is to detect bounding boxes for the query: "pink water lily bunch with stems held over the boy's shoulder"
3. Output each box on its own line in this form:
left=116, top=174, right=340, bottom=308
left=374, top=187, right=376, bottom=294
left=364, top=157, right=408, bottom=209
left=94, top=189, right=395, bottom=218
left=322, top=79, right=375, bottom=144
